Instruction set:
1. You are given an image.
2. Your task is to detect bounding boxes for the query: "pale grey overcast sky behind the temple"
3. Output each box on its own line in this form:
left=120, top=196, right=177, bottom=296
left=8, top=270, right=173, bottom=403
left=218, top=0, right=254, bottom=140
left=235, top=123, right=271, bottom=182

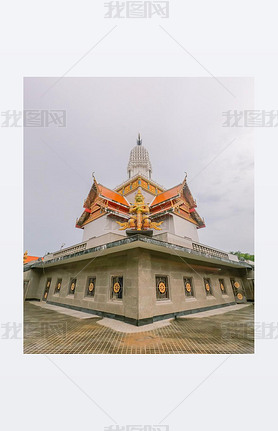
left=24, top=78, right=254, bottom=256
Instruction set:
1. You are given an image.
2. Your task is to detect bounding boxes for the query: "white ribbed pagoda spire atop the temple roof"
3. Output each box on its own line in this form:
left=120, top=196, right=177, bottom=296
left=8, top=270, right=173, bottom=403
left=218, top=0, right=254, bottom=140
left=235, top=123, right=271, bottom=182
left=127, top=133, right=152, bottom=179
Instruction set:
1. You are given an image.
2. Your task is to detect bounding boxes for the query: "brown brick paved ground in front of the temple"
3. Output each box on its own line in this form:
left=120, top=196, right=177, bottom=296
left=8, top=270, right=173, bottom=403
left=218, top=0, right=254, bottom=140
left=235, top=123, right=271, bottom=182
left=24, top=302, right=254, bottom=354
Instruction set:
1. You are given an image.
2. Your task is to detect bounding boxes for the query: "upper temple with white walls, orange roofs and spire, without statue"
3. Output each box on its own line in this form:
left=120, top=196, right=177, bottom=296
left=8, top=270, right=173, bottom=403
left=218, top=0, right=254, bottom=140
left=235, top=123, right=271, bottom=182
left=76, top=135, right=205, bottom=241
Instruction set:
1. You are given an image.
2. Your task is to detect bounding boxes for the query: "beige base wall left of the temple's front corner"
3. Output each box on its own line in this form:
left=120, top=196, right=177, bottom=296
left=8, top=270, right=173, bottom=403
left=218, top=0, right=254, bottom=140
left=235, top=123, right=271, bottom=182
left=29, top=250, right=138, bottom=319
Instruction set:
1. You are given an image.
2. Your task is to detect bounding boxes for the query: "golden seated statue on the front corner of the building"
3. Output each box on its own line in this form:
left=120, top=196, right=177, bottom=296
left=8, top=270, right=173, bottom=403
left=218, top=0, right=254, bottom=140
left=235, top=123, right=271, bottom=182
left=117, top=189, right=163, bottom=235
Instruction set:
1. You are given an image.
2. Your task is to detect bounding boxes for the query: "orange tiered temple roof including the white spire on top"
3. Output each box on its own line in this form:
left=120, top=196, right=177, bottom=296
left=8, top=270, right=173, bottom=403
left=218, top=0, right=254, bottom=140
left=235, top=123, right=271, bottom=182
left=76, top=134, right=205, bottom=229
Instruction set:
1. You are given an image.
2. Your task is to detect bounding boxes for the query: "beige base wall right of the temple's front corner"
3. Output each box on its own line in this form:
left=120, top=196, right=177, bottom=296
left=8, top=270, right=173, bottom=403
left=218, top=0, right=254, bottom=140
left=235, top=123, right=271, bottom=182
left=136, top=251, right=237, bottom=319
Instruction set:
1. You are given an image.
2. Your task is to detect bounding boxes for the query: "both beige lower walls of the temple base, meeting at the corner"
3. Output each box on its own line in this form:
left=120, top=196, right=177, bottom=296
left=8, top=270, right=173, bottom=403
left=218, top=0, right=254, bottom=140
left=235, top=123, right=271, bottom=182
left=24, top=247, right=250, bottom=324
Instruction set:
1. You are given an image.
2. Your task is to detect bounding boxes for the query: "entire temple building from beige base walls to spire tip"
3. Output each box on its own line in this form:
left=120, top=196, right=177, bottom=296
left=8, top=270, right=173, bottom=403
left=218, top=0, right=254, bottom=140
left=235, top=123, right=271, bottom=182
left=24, top=134, right=254, bottom=325
